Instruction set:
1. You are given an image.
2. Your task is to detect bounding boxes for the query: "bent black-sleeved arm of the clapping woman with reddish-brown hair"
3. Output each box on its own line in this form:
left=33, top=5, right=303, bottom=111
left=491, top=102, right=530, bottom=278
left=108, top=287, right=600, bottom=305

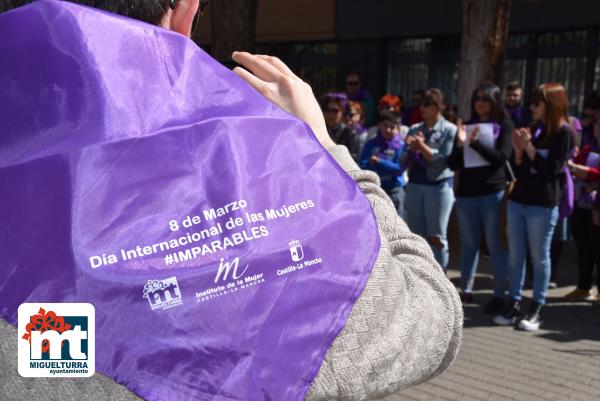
left=524, top=128, right=571, bottom=180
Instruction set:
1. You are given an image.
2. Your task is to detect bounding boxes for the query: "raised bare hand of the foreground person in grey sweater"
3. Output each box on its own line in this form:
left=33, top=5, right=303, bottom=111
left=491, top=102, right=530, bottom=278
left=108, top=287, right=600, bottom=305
left=232, top=52, right=335, bottom=149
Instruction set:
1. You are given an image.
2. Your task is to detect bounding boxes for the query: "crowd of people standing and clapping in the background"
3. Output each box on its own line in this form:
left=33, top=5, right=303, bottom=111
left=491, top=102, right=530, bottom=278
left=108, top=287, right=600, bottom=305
left=321, top=72, right=600, bottom=331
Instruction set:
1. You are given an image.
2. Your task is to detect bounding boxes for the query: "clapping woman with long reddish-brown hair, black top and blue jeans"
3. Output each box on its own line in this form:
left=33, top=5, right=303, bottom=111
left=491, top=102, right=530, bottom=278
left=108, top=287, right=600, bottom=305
left=494, top=83, right=572, bottom=331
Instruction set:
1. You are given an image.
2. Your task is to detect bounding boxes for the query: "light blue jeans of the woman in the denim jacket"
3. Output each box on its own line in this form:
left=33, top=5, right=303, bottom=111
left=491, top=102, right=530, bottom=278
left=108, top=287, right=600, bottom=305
left=405, top=182, right=454, bottom=271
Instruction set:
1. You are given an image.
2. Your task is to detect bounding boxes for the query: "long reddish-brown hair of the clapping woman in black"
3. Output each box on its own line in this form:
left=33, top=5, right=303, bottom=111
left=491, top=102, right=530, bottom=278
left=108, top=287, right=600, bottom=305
left=532, top=82, right=569, bottom=138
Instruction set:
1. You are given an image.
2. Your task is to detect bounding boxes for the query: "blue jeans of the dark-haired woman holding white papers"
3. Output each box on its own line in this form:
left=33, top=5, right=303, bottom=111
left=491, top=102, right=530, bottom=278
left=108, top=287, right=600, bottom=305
left=456, top=191, right=508, bottom=297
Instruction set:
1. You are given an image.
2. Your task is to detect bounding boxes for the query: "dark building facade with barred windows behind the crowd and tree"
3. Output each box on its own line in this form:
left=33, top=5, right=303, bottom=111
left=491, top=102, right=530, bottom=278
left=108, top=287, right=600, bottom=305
left=196, top=0, right=600, bottom=115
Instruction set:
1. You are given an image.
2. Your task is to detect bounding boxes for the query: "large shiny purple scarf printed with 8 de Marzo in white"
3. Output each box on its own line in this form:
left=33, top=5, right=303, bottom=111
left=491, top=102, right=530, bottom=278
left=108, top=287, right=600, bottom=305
left=0, top=0, right=379, bottom=401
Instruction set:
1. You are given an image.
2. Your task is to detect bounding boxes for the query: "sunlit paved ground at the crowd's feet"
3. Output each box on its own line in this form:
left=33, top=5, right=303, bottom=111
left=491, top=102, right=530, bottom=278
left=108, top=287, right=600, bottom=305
left=385, top=243, right=600, bottom=401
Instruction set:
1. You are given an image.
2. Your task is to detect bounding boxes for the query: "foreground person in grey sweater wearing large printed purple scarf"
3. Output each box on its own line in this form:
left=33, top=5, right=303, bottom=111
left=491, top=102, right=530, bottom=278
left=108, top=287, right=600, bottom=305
left=0, top=0, right=463, bottom=401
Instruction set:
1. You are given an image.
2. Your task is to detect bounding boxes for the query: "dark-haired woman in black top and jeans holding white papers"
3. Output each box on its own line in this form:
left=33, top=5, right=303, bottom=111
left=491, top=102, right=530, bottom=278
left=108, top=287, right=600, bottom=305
left=448, top=82, right=514, bottom=314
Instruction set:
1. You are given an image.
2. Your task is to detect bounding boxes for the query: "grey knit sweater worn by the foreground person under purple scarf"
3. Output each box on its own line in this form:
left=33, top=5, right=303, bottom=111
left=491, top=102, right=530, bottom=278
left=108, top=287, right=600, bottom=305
left=0, top=146, right=463, bottom=401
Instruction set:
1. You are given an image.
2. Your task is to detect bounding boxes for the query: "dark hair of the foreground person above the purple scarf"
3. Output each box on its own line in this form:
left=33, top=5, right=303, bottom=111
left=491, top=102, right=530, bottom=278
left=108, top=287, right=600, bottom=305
left=0, top=0, right=167, bottom=25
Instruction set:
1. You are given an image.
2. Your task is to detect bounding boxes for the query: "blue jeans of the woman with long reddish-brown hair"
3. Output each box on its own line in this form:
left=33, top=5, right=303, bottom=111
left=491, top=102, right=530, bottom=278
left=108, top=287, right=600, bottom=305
left=507, top=201, right=558, bottom=304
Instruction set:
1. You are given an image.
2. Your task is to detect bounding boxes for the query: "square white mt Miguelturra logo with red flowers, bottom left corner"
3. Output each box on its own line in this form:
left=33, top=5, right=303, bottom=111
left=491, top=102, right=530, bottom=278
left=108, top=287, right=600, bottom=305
left=18, top=303, right=95, bottom=377
